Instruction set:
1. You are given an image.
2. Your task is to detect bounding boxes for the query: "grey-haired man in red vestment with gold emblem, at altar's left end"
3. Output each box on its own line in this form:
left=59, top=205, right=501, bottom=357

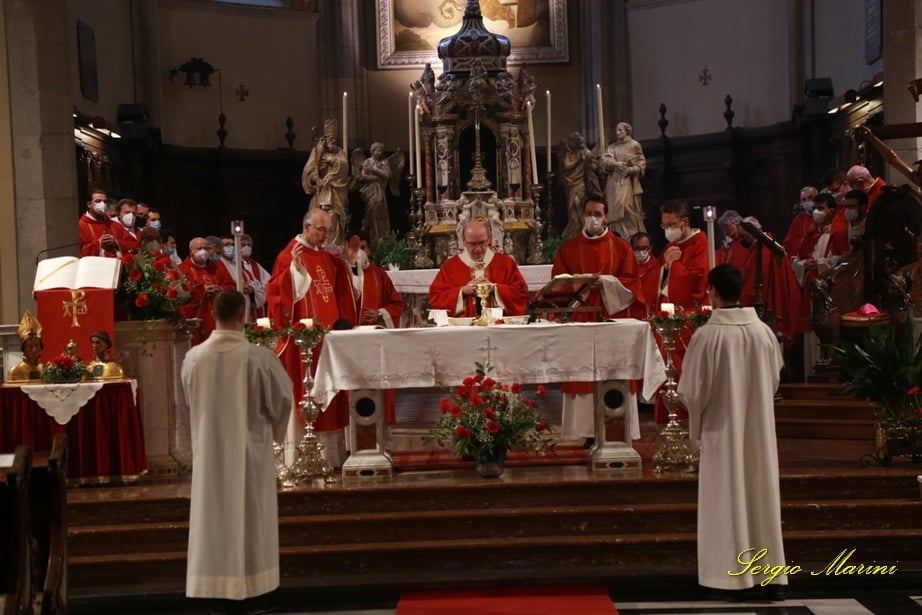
left=266, top=208, right=356, bottom=440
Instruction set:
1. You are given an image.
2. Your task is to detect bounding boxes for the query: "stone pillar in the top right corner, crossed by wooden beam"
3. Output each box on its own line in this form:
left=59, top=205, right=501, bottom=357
left=883, top=0, right=922, bottom=184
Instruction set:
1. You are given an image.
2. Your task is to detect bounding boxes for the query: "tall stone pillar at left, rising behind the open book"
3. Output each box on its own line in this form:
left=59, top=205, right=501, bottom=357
left=4, top=0, right=81, bottom=316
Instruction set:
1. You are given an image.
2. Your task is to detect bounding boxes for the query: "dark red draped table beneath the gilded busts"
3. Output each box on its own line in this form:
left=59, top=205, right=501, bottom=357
left=0, top=380, right=147, bottom=484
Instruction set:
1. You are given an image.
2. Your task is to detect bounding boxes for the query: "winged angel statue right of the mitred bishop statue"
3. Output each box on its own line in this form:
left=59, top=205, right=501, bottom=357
left=351, top=142, right=407, bottom=245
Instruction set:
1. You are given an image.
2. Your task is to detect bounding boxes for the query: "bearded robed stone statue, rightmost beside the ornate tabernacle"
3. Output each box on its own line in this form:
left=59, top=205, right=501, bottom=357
left=600, top=122, right=647, bottom=239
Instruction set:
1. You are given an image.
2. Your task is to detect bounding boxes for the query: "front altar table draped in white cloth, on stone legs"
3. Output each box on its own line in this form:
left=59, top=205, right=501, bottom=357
left=312, top=319, right=666, bottom=476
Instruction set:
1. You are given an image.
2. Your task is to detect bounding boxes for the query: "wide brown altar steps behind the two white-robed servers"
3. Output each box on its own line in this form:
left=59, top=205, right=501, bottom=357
left=68, top=384, right=922, bottom=604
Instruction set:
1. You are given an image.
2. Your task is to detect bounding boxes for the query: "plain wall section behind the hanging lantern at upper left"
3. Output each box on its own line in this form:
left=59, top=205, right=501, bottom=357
left=155, top=0, right=320, bottom=150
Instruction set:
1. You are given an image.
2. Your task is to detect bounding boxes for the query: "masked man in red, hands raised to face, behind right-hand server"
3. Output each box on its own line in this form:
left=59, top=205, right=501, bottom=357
left=653, top=200, right=708, bottom=425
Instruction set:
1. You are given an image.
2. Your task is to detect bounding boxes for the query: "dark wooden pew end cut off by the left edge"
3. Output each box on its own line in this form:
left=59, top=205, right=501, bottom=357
left=0, top=446, right=33, bottom=615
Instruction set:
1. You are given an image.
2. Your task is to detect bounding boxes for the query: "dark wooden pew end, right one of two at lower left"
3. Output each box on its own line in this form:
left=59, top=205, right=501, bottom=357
left=30, top=433, right=68, bottom=615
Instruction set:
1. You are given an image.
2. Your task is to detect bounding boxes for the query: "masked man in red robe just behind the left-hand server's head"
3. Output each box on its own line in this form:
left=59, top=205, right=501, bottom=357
left=179, top=237, right=237, bottom=346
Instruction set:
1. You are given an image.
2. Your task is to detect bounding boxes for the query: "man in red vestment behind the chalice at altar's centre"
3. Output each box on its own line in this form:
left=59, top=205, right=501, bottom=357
left=429, top=220, right=528, bottom=317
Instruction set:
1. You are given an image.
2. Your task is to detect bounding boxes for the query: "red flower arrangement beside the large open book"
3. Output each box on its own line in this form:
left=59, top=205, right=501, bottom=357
left=117, top=250, right=189, bottom=323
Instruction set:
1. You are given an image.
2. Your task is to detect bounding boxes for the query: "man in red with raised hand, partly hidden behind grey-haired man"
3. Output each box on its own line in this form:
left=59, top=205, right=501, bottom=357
left=343, top=229, right=403, bottom=425
